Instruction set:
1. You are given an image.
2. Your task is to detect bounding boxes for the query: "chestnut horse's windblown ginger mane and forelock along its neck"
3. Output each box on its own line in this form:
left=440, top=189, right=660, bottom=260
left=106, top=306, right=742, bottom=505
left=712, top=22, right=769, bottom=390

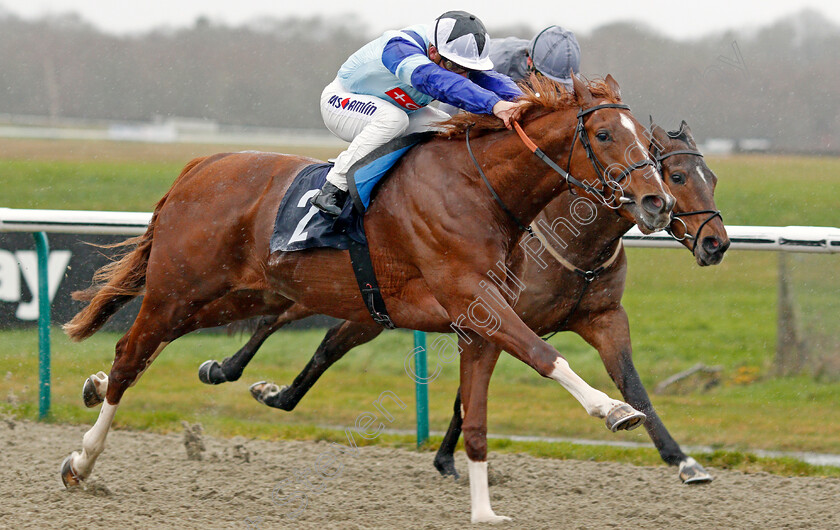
left=439, top=76, right=621, bottom=138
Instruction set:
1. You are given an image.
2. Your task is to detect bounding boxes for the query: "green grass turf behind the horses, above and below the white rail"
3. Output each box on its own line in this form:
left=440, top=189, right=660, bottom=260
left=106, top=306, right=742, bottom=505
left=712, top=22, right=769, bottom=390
left=0, top=143, right=840, bottom=476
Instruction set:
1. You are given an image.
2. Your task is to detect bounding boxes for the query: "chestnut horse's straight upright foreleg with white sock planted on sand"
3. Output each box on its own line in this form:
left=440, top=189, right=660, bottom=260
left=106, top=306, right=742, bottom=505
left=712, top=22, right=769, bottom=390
left=459, top=333, right=510, bottom=523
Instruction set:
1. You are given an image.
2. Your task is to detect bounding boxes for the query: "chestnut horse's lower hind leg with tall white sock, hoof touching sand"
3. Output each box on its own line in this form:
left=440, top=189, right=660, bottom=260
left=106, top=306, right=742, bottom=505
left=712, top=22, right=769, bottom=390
left=61, top=303, right=176, bottom=487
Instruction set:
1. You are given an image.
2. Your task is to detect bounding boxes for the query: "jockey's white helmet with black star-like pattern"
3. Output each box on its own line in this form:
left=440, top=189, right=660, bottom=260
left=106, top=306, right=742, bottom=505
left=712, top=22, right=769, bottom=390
left=429, top=11, right=493, bottom=70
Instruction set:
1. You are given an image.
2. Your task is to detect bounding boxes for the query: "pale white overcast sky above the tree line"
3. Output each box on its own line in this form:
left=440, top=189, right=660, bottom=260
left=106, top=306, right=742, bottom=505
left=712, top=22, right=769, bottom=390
left=0, top=0, right=840, bottom=38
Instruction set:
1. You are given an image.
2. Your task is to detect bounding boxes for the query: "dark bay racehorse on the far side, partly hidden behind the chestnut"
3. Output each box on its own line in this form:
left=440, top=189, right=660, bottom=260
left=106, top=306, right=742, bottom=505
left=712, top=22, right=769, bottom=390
left=199, top=117, right=729, bottom=484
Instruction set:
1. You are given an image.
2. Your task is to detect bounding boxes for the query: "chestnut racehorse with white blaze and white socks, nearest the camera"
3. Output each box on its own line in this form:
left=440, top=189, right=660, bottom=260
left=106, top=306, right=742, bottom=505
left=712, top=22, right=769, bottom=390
left=62, top=76, right=674, bottom=522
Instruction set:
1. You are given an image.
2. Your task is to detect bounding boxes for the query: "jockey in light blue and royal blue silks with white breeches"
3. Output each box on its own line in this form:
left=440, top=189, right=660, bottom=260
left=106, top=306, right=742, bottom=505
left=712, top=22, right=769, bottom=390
left=312, top=11, right=522, bottom=215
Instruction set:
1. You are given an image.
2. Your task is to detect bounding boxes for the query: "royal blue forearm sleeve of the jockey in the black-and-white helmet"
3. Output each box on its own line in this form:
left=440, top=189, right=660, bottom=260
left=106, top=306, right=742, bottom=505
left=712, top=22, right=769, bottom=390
left=411, top=62, right=501, bottom=114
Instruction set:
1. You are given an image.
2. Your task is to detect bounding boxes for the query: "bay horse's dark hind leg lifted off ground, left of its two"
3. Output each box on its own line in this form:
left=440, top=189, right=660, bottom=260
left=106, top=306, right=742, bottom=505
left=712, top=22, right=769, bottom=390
left=198, top=304, right=315, bottom=385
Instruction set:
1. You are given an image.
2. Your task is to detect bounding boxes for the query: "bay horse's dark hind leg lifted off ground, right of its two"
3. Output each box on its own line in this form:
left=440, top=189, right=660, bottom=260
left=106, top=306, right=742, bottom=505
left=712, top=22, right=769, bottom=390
left=251, top=321, right=383, bottom=411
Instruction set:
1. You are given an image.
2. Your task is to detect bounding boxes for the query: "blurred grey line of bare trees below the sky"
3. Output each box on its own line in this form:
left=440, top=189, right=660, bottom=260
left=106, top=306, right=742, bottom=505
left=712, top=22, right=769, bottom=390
left=0, top=11, right=840, bottom=152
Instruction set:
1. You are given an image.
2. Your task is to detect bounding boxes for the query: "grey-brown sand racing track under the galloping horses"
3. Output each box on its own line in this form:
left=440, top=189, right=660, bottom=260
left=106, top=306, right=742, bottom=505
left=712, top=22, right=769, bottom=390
left=0, top=420, right=840, bottom=530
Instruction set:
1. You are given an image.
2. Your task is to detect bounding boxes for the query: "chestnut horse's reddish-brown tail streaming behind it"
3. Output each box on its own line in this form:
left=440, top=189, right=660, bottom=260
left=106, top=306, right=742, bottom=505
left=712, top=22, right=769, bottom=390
left=62, top=158, right=204, bottom=342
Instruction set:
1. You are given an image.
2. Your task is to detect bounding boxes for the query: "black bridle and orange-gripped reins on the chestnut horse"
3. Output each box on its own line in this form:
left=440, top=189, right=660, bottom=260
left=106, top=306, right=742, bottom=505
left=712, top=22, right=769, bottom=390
left=466, top=103, right=657, bottom=236
